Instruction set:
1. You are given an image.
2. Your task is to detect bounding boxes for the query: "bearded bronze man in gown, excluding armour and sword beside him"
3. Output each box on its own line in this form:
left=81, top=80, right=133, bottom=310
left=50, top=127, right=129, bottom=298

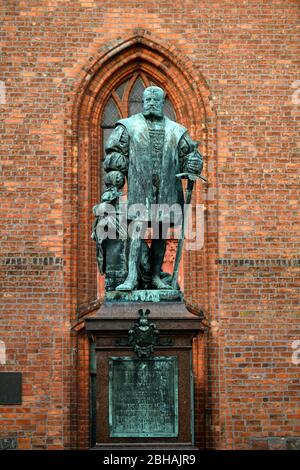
left=104, top=86, right=203, bottom=291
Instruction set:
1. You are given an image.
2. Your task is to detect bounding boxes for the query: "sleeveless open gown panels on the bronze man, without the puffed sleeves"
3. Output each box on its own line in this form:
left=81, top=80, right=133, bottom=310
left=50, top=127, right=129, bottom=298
left=116, top=113, right=187, bottom=220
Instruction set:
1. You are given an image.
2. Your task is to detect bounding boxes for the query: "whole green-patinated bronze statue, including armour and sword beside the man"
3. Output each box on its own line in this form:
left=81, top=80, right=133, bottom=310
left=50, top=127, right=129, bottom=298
left=92, top=87, right=203, bottom=301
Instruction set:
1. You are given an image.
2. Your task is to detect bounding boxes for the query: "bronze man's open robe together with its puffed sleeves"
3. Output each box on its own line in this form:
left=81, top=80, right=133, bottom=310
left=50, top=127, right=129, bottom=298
left=104, top=114, right=202, bottom=220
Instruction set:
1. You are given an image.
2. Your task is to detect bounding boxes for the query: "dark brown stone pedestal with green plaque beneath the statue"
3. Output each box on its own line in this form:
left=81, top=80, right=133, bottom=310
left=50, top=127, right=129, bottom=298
left=86, top=302, right=202, bottom=449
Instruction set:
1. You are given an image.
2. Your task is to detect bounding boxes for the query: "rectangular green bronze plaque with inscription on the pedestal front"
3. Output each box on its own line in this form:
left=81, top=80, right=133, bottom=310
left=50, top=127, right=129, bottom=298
left=109, top=356, right=178, bottom=437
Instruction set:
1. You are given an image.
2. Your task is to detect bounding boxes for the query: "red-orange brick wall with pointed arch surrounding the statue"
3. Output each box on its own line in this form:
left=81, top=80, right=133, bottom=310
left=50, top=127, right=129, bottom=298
left=0, top=0, right=300, bottom=449
